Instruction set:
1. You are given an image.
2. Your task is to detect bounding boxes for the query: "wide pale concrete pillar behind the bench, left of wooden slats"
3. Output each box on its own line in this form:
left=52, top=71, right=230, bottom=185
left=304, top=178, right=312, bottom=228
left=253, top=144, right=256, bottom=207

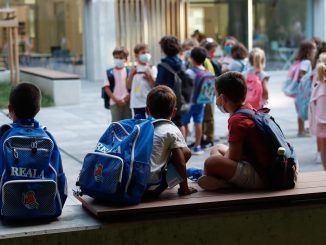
left=84, top=0, right=116, bottom=81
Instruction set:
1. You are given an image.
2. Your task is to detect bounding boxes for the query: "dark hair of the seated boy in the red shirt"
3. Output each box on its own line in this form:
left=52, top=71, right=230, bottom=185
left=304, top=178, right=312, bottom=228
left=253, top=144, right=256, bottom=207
left=215, top=71, right=247, bottom=103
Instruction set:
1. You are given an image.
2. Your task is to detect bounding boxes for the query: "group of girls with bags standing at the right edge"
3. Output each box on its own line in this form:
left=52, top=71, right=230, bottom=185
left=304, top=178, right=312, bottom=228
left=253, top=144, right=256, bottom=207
left=283, top=40, right=326, bottom=169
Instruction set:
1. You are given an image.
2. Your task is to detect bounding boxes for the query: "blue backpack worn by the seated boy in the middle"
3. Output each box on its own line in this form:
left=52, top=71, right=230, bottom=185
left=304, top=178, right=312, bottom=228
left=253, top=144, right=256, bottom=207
left=77, top=118, right=154, bottom=204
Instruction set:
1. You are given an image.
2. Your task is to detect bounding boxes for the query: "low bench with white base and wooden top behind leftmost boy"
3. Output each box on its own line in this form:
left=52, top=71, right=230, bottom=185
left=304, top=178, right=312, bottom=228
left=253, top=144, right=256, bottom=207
left=20, top=67, right=81, bottom=106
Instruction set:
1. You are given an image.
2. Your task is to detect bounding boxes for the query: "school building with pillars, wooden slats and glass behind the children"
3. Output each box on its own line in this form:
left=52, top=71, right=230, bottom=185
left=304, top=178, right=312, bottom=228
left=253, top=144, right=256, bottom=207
left=0, top=0, right=326, bottom=80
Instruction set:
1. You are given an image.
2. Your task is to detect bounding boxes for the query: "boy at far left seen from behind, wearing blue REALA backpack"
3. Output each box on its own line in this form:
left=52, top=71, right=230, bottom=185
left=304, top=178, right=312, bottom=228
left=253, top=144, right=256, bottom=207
left=0, top=83, right=67, bottom=218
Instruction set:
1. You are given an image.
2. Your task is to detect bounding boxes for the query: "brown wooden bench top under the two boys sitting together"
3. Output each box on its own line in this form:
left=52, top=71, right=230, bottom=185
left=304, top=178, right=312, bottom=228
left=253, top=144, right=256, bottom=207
left=76, top=172, right=326, bottom=218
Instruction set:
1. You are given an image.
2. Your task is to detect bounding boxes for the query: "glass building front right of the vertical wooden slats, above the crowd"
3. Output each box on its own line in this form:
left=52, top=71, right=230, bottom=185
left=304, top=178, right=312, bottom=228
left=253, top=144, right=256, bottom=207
left=189, top=0, right=313, bottom=70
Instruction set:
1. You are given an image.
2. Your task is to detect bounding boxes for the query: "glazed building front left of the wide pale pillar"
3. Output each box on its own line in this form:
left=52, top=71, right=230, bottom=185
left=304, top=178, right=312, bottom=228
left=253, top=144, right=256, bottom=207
left=0, top=0, right=84, bottom=76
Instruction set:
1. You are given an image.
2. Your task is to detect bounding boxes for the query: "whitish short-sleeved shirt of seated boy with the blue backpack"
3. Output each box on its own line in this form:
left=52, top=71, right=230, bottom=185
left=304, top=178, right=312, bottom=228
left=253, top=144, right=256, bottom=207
left=147, top=122, right=187, bottom=184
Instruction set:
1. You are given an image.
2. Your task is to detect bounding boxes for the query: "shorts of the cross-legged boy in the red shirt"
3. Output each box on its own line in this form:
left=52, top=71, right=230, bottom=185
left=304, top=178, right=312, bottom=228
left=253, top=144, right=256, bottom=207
left=228, top=161, right=264, bottom=190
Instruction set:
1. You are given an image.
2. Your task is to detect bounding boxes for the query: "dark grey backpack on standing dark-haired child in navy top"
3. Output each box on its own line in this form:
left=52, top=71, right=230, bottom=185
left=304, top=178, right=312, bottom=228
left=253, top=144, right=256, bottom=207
left=159, top=62, right=194, bottom=116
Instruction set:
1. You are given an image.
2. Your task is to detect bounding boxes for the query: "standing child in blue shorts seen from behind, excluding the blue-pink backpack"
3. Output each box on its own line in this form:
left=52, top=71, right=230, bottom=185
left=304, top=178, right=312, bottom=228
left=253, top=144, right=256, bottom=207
left=181, top=47, right=212, bottom=155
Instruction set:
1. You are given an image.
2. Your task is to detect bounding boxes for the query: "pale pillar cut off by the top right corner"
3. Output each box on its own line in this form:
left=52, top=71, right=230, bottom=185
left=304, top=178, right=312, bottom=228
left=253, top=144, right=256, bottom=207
left=313, top=0, right=326, bottom=40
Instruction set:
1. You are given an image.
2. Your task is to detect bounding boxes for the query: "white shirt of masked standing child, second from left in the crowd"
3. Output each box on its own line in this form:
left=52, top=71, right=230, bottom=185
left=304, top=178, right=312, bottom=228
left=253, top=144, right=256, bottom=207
left=130, top=65, right=157, bottom=108
